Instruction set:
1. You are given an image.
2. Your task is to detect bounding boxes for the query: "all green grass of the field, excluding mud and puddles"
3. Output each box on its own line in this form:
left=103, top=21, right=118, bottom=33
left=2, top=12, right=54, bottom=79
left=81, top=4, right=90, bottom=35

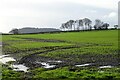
left=2, top=30, right=120, bottom=80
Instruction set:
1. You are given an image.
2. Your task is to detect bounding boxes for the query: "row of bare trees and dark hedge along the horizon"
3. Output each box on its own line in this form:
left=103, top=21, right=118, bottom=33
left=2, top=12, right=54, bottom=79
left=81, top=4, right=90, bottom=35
left=9, top=18, right=119, bottom=34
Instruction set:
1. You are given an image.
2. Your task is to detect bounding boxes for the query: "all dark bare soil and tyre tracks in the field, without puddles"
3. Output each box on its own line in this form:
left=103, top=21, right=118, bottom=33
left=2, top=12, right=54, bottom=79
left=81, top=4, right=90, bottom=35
left=4, top=37, right=120, bottom=68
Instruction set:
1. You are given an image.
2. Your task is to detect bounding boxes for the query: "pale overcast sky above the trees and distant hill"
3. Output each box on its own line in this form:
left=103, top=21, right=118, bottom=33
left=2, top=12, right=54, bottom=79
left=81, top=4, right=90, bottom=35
left=0, top=0, right=119, bottom=32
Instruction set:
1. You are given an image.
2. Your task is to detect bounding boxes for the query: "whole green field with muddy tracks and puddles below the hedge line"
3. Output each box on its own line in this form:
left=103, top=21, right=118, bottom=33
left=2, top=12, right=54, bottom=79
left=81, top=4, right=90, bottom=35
left=0, top=30, right=120, bottom=79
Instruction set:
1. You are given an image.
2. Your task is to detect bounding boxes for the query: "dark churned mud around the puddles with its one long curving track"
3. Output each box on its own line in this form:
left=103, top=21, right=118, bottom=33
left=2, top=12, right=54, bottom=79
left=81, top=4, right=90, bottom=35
left=19, top=47, right=120, bottom=68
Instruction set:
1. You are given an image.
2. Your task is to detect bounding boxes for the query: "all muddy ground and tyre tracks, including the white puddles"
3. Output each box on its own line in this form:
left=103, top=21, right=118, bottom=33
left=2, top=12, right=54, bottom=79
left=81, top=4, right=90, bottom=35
left=0, top=37, right=120, bottom=72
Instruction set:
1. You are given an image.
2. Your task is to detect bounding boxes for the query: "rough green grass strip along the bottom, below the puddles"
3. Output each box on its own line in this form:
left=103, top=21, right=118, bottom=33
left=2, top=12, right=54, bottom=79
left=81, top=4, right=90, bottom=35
left=2, top=67, right=120, bottom=80
